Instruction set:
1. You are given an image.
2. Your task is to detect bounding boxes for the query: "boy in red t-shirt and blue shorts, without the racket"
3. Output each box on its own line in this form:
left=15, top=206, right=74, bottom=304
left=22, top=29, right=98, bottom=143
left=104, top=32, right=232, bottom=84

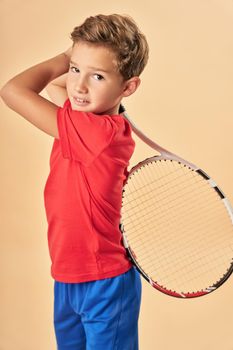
left=1, top=15, right=148, bottom=350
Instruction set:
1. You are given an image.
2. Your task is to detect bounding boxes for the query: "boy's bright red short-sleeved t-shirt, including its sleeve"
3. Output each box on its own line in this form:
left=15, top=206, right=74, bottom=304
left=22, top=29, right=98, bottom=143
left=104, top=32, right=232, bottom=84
left=44, top=99, right=135, bottom=283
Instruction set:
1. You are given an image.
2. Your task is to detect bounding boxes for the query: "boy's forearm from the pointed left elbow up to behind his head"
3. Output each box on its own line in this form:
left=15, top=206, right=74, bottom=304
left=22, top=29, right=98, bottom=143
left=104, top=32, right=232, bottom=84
left=2, top=50, right=70, bottom=93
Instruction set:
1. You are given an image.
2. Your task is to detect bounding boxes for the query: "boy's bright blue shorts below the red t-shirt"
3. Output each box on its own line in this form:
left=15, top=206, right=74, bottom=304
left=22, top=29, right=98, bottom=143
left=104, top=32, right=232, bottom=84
left=54, top=267, right=141, bottom=350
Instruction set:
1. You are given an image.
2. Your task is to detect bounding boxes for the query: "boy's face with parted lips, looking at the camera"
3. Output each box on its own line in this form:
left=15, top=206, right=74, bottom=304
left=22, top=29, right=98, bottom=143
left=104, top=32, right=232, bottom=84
left=66, top=42, right=127, bottom=115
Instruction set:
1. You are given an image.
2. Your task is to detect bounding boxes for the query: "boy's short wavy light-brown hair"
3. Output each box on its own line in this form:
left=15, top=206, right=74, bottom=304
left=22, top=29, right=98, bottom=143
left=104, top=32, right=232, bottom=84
left=71, top=14, right=149, bottom=80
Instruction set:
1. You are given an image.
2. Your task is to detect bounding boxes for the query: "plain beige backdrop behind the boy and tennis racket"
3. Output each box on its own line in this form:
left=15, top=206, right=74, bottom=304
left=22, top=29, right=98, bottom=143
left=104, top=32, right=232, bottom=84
left=0, top=0, right=233, bottom=350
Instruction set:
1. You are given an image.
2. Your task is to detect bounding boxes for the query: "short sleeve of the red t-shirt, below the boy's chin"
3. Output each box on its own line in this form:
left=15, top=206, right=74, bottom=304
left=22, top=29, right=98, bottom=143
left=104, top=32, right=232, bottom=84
left=57, top=99, right=117, bottom=165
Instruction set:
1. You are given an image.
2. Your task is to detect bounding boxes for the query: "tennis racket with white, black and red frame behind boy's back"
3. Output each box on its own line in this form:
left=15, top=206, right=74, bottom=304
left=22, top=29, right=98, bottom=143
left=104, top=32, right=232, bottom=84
left=120, top=110, right=233, bottom=298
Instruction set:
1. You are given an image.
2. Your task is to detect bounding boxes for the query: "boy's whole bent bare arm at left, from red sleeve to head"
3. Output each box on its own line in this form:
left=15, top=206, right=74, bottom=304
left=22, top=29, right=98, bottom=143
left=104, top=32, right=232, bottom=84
left=0, top=48, right=71, bottom=138
